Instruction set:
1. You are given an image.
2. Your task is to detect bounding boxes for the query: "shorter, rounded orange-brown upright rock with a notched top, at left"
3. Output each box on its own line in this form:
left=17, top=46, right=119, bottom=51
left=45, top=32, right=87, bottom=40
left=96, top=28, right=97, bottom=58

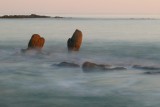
left=28, top=34, right=45, bottom=49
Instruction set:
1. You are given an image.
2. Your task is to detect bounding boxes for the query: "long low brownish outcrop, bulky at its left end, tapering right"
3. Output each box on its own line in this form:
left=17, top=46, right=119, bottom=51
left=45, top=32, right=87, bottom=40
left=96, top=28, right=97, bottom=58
left=82, top=62, right=126, bottom=72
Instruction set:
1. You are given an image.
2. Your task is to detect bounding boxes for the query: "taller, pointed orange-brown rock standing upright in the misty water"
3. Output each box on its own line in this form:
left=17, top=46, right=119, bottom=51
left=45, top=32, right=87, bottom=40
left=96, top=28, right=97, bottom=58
left=67, top=29, right=82, bottom=51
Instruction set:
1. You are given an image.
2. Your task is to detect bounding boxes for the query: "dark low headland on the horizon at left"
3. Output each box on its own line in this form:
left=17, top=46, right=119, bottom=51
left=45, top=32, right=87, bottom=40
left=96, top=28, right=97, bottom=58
left=0, top=14, right=64, bottom=19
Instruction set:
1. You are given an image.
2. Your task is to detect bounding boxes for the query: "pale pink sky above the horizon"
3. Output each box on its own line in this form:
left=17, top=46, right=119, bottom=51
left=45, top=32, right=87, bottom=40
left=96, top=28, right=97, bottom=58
left=0, top=0, right=160, bottom=15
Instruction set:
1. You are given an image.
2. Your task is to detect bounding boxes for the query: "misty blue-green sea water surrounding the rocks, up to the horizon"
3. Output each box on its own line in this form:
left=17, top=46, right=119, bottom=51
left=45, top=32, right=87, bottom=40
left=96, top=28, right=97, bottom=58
left=0, top=18, right=160, bottom=107
